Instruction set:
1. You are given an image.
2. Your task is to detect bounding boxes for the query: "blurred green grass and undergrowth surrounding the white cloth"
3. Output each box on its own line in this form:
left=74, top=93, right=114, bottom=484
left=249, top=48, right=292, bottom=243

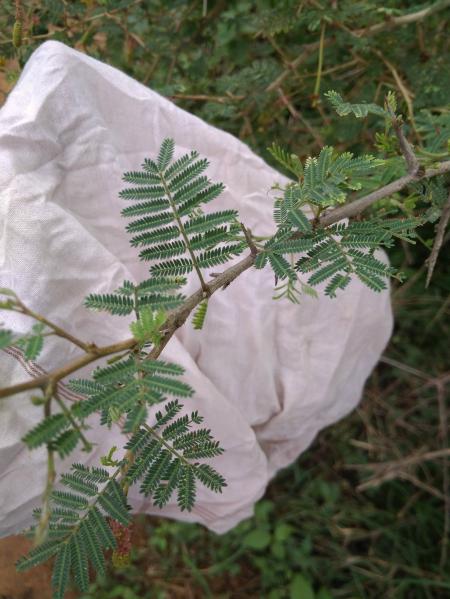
left=0, top=0, right=450, bottom=599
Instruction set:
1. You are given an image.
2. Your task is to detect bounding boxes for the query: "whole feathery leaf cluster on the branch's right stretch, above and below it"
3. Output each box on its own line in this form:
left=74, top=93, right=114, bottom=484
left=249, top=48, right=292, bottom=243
left=255, top=92, right=447, bottom=302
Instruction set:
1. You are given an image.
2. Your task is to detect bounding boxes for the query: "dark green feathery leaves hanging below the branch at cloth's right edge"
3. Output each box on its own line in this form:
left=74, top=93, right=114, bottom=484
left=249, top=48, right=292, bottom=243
left=255, top=169, right=423, bottom=302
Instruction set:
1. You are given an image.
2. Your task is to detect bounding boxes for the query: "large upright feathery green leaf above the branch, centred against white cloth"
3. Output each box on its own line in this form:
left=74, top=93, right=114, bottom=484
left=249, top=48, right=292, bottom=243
left=120, top=139, right=245, bottom=284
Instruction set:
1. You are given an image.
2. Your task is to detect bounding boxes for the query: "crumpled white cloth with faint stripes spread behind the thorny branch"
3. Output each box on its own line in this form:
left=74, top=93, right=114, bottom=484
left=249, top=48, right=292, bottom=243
left=0, top=42, right=392, bottom=536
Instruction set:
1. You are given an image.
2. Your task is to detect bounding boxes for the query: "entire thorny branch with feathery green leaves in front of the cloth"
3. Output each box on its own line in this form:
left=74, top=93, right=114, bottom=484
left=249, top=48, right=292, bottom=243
left=0, top=85, right=450, bottom=599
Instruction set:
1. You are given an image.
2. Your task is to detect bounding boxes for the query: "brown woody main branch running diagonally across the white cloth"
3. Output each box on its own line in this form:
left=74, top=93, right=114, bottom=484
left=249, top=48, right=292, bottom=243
left=0, top=160, right=450, bottom=399
